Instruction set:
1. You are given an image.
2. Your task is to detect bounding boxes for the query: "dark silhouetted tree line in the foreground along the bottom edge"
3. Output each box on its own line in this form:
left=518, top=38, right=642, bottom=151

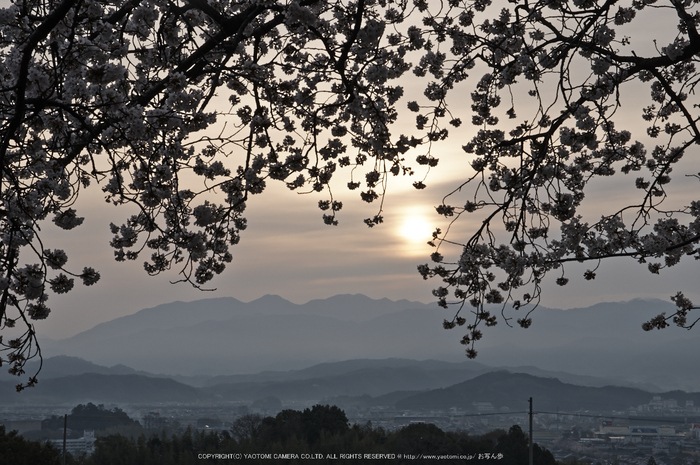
left=0, top=405, right=557, bottom=465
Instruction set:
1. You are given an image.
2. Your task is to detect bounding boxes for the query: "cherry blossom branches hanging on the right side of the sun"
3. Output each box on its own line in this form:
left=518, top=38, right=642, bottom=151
left=408, top=0, right=700, bottom=357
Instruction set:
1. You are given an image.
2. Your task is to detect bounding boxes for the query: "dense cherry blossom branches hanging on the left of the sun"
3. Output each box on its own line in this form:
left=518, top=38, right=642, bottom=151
left=0, top=0, right=420, bottom=389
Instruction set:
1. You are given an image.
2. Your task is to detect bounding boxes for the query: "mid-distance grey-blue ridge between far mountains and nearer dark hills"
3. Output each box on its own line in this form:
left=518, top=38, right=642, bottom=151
left=0, top=355, right=644, bottom=402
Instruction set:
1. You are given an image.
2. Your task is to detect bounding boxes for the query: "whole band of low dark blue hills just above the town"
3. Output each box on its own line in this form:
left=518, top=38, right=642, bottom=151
left=0, top=357, right=700, bottom=412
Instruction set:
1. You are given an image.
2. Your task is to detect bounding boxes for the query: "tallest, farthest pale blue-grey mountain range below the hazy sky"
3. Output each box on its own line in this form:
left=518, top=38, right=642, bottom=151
left=43, top=295, right=700, bottom=390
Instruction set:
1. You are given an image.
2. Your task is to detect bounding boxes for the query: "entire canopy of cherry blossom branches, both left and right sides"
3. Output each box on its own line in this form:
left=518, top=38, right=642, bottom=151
left=0, top=0, right=700, bottom=388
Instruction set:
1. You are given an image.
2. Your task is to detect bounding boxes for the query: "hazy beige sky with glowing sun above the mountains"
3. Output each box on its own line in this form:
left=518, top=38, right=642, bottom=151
left=23, top=1, right=700, bottom=338
